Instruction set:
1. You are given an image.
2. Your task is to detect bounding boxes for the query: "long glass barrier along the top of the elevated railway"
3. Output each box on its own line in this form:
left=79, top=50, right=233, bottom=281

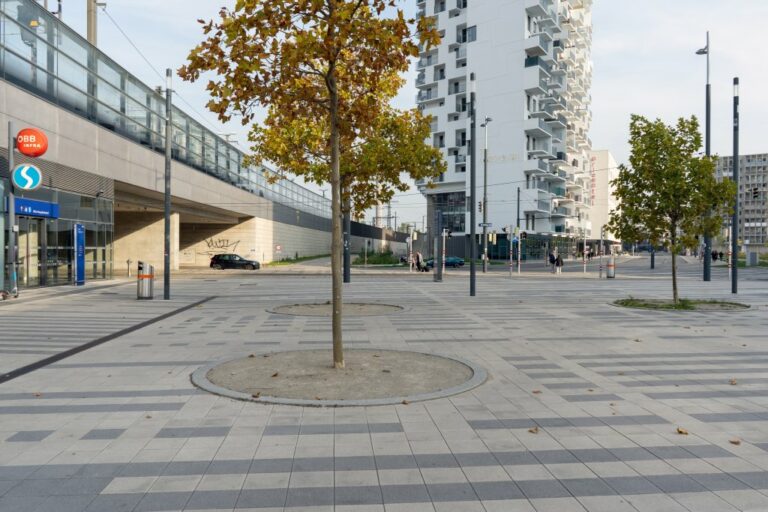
left=0, top=0, right=331, bottom=218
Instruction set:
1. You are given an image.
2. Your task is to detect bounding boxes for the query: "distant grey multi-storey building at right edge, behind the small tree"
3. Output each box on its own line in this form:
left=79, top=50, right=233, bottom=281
left=716, top=153, right=768, bottom=248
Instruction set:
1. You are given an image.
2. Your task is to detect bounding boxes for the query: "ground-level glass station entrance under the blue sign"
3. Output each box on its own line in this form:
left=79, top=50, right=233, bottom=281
left=6, top=188, right=114, bottom=288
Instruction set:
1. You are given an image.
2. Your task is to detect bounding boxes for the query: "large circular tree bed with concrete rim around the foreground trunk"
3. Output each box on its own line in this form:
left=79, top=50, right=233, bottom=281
left=192, top=348, right=487, bottom=407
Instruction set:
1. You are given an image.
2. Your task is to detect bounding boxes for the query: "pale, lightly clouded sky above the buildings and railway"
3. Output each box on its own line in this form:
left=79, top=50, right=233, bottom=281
left=49, top=0, right=768, bottom=226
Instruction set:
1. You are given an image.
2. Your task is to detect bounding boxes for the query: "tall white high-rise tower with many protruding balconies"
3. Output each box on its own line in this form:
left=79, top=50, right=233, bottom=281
left=416, top=0, right=599, bottom=249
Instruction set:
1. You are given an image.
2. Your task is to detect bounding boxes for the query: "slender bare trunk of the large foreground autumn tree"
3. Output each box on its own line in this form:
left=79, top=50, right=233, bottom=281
left=328, top=75, right=344, bottom=368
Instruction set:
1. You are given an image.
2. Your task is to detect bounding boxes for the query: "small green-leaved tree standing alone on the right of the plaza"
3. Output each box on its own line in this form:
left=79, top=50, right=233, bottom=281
left=608, top=115, right=736, bottom=304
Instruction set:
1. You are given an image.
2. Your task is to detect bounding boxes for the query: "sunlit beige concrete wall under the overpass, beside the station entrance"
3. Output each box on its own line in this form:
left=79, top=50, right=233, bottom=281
left=114, top=212, right=179, bottom=275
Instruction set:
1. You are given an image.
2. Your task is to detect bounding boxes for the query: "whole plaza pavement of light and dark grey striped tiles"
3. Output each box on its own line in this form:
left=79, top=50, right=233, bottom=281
left=0, top=264, right=768, bottom=512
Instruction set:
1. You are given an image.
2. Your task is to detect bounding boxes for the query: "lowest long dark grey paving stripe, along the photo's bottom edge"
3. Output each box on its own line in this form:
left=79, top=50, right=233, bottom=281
left=63, top=472, right=768, bottom=510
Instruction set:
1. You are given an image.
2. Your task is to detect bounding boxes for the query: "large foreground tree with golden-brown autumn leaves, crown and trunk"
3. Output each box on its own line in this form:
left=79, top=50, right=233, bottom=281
left=179, top=0, right=439, bottom=368
